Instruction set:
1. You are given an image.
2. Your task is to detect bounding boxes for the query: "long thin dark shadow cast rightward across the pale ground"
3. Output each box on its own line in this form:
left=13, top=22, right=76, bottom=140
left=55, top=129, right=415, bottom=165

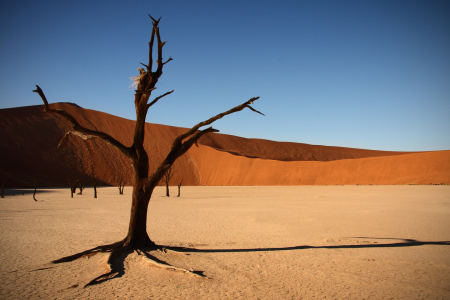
left=165, top=237, right=450, bottom=253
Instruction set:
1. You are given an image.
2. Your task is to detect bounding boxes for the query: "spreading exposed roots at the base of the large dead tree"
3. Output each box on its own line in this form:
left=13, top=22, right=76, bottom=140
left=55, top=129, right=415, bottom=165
left=52, top=240, right=208, bottom=288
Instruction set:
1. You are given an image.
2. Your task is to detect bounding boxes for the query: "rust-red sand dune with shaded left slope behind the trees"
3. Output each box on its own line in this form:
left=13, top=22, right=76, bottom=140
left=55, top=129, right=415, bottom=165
left=0, top=103, right=450, bottom=187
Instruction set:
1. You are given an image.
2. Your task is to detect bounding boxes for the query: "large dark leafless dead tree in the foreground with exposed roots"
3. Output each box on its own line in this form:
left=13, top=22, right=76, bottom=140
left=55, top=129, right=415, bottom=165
left=34, top=16, right=261, bottom=285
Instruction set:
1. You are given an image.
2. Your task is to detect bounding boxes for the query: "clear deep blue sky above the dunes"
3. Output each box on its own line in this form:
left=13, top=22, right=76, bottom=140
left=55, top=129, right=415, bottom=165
left=0, top=0, right=450, bottom=151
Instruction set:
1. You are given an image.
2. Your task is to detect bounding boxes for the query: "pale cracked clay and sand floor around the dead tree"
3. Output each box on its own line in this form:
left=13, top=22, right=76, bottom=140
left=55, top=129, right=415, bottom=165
left=0, top=186, right=450, bottom=299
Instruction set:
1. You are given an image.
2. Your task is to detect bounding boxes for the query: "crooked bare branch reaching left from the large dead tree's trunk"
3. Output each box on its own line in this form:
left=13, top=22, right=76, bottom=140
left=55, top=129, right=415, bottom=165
left=33, top=85, right=132, bottom=158
